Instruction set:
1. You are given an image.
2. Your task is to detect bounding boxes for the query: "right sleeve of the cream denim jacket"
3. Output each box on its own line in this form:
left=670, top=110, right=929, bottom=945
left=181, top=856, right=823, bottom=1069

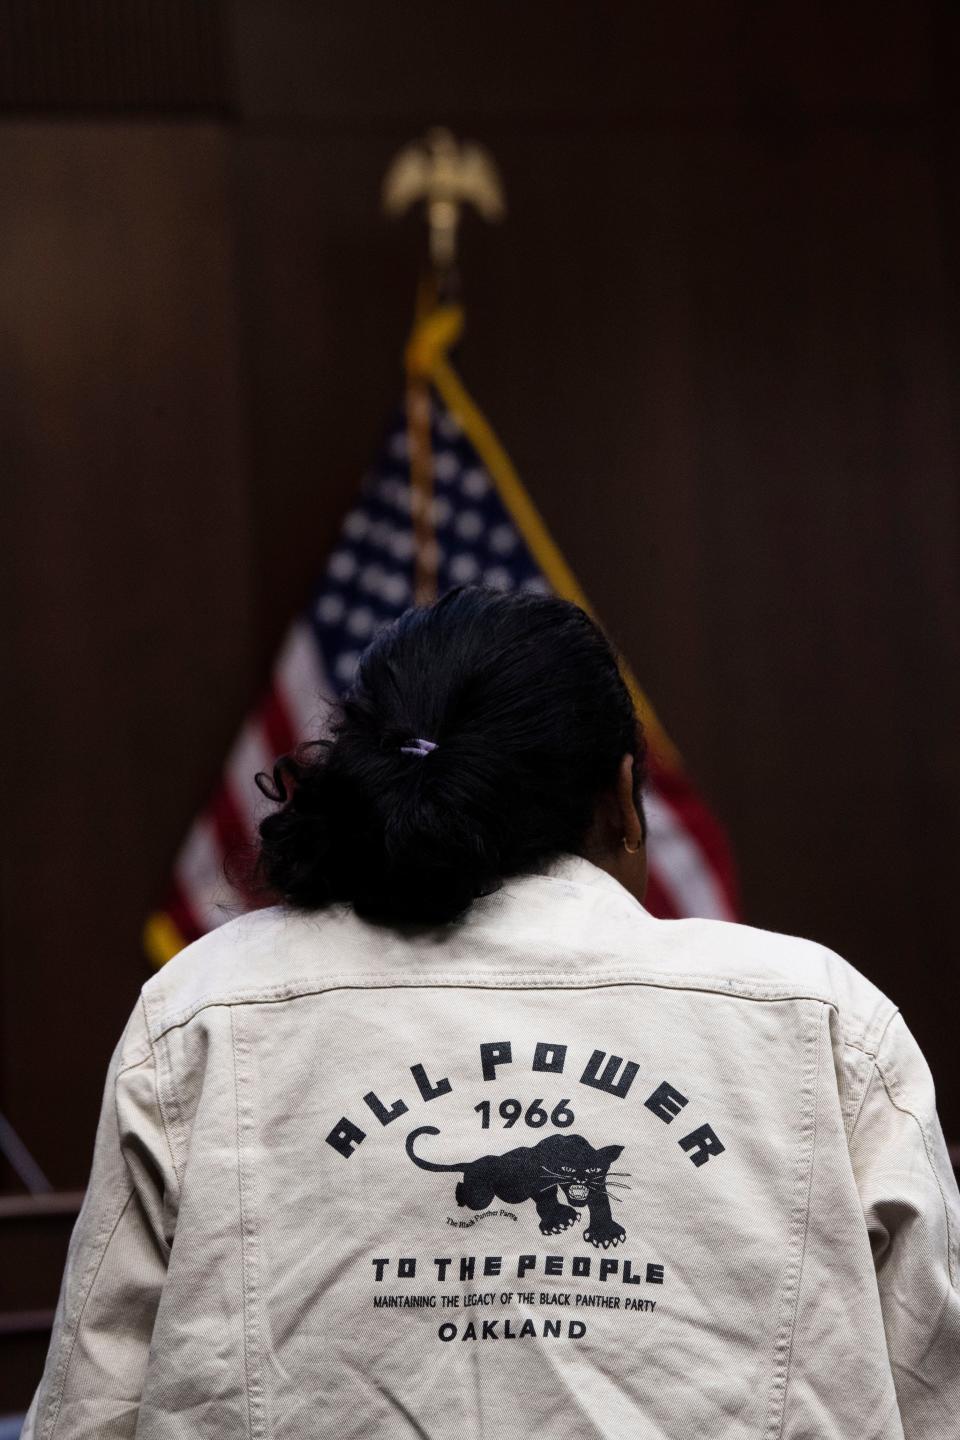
left=851, top=1014, right=960, bottom=1440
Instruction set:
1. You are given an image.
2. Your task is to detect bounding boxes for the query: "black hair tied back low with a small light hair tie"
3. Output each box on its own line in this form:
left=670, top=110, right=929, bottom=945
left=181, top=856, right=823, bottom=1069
left=256, top=586, right=646, bottom=923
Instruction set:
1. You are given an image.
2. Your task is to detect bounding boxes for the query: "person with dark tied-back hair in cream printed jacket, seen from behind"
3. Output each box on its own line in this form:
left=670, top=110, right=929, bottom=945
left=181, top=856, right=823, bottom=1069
left=24, top=588, right=960, bottom=1440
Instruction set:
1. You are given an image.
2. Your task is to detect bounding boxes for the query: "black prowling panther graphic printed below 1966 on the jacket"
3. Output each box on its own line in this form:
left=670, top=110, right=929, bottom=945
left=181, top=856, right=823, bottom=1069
left=407, top=1125, right=632, bottom=1250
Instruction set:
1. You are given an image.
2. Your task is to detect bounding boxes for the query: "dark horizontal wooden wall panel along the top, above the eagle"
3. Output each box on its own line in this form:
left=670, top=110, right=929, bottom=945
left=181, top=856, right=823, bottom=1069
left=229, top=0, right=941, bottom=123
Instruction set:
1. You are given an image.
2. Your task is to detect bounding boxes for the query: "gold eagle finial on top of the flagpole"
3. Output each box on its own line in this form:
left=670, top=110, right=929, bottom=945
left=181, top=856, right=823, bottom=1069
left=383, top=128, right=507, bottom=275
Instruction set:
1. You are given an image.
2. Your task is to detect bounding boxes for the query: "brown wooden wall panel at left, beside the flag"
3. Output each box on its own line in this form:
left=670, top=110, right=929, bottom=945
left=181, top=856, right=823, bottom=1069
left=0, top=122, right=252, bottom=1187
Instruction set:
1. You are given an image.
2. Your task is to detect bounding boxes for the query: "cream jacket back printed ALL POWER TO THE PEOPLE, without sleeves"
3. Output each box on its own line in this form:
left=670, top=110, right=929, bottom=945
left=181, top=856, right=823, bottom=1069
left=138, top=877, right=902, bottom=1440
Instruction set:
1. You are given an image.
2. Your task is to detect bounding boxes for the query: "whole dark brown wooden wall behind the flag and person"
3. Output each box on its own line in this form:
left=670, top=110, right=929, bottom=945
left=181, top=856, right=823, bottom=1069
left=0, top=0, right=960, bottom=1301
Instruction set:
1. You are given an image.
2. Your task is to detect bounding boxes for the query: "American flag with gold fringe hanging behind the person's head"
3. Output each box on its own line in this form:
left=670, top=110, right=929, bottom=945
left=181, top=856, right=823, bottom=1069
left=145, top=315, right=737, bottom=965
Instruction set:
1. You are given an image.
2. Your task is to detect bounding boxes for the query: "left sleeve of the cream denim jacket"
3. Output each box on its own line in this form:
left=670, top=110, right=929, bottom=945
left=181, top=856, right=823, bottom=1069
left=22, top=1002, right=177, bottom=1440
